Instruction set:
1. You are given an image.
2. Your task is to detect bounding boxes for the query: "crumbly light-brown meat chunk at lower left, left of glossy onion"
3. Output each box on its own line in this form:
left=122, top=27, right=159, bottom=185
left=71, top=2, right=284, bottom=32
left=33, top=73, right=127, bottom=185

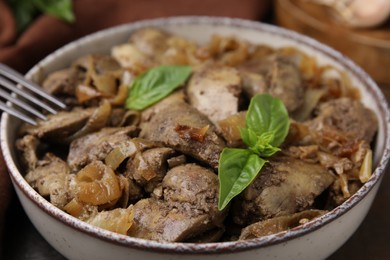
left=25, top=153, right=70, bottom=209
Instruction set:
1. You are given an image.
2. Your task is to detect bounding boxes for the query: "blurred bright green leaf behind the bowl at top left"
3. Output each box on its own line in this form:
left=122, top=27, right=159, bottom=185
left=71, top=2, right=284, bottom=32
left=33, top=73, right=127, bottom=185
left=32, top=0, right=75, bottom=23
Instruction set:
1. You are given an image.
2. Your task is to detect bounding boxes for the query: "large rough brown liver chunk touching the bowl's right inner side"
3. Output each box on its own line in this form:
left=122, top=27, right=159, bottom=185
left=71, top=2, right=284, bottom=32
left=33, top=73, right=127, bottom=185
left=309, top=98, right=378, bottom=142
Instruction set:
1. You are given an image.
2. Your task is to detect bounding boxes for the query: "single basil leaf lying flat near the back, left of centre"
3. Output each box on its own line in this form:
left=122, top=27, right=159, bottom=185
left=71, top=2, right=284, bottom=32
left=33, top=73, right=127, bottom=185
left=126, top=66, right=192, bottom=110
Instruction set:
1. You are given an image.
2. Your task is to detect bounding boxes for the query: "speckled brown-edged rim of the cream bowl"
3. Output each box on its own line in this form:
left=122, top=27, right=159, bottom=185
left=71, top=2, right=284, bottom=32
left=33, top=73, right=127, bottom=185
left=0, top=16, right=390, bottom=254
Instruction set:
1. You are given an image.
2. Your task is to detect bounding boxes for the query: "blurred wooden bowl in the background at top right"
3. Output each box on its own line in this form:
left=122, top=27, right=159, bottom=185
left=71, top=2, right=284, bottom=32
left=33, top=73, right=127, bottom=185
left=275, top=0, right=390, bottom=85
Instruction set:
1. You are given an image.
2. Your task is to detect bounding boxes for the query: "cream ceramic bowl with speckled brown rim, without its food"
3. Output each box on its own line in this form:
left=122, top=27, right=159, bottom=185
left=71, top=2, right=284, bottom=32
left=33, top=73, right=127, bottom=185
left=1, top=17, right=390, bottom=260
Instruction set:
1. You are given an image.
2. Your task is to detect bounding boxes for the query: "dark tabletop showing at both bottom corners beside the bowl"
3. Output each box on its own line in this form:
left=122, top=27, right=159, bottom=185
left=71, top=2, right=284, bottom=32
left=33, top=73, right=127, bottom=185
left=3, top=86, right=390, bottom=260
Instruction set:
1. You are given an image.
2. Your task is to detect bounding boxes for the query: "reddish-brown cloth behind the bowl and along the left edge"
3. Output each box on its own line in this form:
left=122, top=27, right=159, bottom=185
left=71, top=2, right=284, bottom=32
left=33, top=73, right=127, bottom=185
left=0, top=0, right=271, bottom=258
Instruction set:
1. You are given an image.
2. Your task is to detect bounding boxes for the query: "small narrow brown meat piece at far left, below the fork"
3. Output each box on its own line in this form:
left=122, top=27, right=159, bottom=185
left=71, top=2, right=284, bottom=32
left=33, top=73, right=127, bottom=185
left=16, top=135, right=39, bottom=170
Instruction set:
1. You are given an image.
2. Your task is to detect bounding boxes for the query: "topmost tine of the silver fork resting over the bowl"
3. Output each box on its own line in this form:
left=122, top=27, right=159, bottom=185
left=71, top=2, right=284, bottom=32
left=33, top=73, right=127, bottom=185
left=0, top=63, right=66, bottom=108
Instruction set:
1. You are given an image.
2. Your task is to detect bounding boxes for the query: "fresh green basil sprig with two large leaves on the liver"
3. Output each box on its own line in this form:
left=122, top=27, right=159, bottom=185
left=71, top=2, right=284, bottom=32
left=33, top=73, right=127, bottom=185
left=218, top=94, right=290, bottom=210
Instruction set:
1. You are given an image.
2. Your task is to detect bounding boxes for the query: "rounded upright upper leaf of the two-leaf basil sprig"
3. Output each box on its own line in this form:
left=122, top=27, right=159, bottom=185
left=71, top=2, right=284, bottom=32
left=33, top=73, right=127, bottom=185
left=246, top=94, right=290, bottom=146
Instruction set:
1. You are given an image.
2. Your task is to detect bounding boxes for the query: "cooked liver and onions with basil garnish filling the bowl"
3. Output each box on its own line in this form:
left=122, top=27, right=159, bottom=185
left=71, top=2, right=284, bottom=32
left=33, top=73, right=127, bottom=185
left=17, top=28, right=378, bottom=243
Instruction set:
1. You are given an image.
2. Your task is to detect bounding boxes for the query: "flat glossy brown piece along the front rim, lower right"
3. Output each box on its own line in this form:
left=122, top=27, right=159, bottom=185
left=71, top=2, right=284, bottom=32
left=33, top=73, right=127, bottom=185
left=239, top=210, right=326, bottom=240
